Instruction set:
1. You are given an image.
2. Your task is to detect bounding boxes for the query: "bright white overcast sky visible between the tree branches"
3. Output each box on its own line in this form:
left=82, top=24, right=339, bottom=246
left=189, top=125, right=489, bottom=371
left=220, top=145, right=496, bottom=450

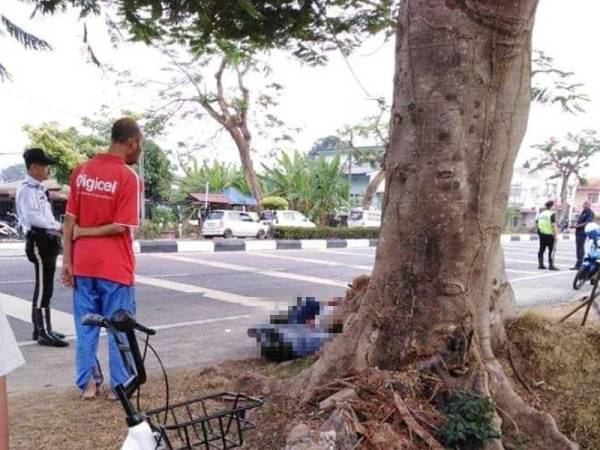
left=0, top=0, right=600, bottom=178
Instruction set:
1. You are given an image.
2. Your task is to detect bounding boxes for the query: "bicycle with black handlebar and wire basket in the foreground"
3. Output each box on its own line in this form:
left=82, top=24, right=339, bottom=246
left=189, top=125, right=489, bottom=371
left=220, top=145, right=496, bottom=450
left=82, top=310, right=263, bottom=450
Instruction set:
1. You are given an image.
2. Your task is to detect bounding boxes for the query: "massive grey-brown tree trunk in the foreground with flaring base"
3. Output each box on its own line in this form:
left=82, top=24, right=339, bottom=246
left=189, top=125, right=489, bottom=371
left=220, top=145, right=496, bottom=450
left=296, top=0, right=576, bottom=450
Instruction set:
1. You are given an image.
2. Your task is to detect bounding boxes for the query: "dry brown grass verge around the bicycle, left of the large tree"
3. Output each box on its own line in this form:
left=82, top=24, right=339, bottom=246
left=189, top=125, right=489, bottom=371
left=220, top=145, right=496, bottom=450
left=9, top=358, right=314, bottom=450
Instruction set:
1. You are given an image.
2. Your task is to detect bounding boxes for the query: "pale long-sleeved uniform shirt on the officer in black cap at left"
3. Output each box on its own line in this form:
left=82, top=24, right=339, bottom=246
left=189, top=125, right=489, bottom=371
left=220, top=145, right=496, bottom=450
left=15, top=175, right=60, bottom=233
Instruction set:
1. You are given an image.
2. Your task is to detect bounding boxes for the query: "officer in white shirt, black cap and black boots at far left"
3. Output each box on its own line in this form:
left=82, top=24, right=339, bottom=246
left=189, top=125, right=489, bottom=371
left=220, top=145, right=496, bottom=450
left=16, top=148, right=69, bottom=347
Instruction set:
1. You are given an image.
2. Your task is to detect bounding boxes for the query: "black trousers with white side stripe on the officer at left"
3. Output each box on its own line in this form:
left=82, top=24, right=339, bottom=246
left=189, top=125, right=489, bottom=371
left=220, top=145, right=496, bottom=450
left=25, top=227, right=60, bottom=310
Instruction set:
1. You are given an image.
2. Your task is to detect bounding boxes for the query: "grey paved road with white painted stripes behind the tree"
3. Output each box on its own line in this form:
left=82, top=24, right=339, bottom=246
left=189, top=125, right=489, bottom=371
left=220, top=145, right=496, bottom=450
left=0, top=241, right=574, bottom=392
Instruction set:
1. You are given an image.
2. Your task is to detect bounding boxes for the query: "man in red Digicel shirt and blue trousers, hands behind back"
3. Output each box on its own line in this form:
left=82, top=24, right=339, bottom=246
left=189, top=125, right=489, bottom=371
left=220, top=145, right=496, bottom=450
left=62, top=118, right=143, bottom=399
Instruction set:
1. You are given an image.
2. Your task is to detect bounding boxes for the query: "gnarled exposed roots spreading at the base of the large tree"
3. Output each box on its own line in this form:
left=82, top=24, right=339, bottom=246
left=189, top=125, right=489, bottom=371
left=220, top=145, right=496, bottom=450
left=275, top=272, right=578, bottom=450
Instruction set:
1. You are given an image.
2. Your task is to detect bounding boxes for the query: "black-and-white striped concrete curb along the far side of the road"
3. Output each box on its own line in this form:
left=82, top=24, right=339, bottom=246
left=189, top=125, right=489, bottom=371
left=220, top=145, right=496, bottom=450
left=0, top=234, right=575, bottom=257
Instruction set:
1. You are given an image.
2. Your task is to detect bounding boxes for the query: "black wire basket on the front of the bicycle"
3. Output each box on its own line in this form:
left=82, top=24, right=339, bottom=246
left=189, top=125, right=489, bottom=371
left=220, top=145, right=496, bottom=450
left=146, top=392, right=263, bottom=450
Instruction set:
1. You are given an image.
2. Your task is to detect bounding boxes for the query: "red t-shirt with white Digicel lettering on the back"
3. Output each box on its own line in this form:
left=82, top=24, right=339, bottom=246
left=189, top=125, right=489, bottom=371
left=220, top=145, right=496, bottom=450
left=67, top=153, right=140, bottom=285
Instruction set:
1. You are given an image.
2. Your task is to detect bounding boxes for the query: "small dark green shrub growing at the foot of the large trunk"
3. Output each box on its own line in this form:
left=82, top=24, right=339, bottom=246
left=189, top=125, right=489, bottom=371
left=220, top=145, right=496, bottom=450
left=437, top=391, right=500, bottom=450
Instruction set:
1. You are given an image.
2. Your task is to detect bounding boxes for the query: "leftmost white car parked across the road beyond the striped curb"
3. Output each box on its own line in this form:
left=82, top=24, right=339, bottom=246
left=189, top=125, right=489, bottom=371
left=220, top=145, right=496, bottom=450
left=202, top=209, right=269, bottom=239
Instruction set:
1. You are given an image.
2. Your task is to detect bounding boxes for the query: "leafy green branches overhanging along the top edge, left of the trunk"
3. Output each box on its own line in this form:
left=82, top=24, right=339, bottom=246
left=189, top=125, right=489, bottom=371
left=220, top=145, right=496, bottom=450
left=22, top=0, right=399, bottom=64
